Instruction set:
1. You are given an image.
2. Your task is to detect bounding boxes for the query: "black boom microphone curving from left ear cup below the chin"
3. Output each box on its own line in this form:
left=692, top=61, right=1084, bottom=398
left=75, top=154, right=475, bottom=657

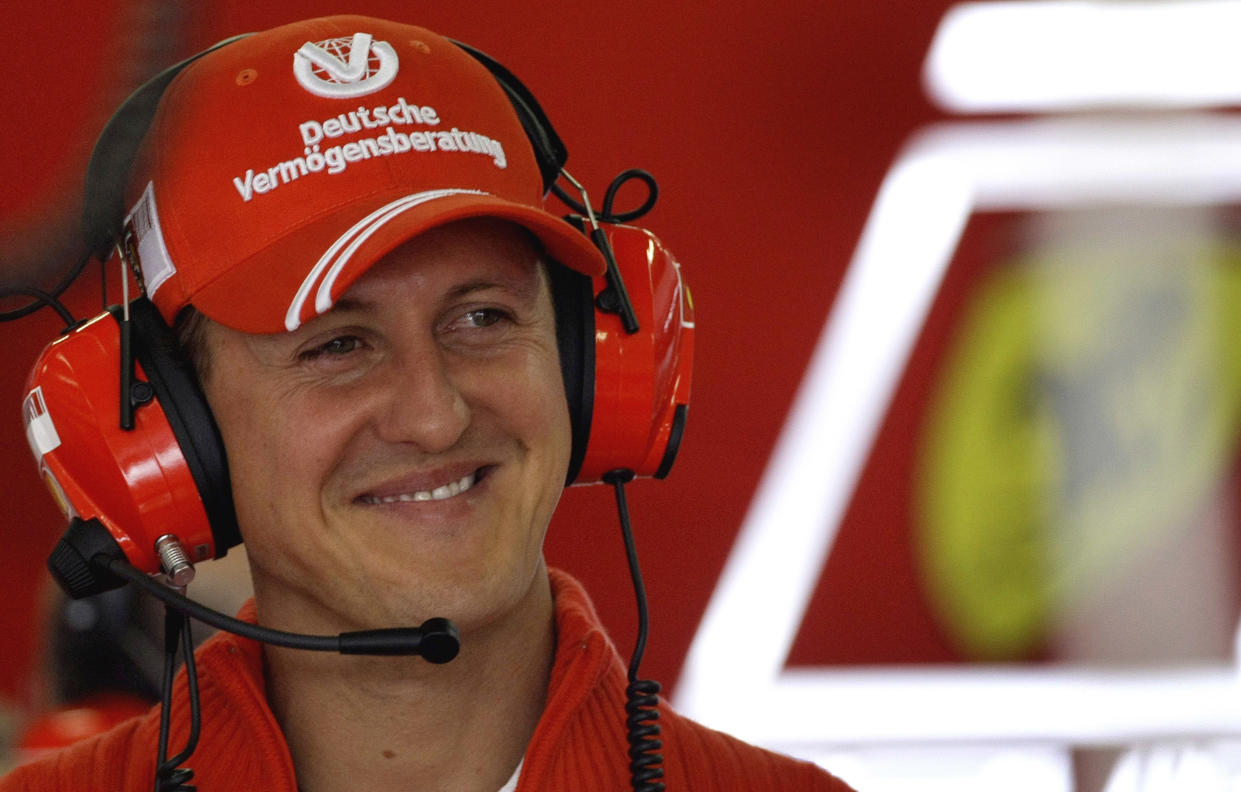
left=47, top=518, right=460, bottom=663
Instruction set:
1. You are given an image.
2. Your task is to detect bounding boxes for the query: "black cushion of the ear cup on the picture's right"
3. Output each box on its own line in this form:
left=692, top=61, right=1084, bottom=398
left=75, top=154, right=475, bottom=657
left=547, top=262, right=594, bottom=485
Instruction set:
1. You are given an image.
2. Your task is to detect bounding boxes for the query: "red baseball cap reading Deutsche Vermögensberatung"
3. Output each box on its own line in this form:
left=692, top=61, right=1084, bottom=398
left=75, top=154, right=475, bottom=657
left=118, top=16, right=606, bottom=333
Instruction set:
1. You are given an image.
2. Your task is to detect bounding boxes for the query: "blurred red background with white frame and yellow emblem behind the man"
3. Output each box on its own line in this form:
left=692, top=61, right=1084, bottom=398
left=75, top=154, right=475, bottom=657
left=0, top=0, right=1241, bottom=792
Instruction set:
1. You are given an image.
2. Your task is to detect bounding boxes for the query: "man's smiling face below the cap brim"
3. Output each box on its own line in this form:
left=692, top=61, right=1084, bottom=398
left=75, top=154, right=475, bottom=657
left=204, top=220, right=570, bottom=632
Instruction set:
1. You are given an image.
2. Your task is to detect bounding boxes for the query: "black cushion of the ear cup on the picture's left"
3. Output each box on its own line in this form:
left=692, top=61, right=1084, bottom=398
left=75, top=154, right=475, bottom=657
left=129, top=297, right=241, bottom=557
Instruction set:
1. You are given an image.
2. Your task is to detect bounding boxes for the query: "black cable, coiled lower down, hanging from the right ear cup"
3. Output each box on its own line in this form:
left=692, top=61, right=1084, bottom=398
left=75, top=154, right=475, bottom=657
left=603, top=469, right=664, bottom=792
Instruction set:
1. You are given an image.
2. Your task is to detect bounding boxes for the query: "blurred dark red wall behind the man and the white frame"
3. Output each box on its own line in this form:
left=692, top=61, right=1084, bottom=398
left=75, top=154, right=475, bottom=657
left=0, top=0, right=953, bottom=715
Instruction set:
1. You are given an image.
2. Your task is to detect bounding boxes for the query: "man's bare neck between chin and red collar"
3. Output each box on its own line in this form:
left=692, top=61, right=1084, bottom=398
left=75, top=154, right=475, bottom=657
left=264, top=575, right=555, bottom=792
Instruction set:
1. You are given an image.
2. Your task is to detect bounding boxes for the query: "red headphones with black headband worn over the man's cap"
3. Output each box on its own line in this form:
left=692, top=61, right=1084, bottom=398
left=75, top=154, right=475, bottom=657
left=22, top=32, right=694, bottom=596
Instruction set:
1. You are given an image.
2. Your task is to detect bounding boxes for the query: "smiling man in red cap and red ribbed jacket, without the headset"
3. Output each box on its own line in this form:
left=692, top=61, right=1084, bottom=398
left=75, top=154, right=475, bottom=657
left=0, top=12, right=848, bottom=792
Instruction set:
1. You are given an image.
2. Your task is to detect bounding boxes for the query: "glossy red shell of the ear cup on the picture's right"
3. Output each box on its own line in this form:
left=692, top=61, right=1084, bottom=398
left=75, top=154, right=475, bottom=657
left=573, top=225, right=694, bottom=484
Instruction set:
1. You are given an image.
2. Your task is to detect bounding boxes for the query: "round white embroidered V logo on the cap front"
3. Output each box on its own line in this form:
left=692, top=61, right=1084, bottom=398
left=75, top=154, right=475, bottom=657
left=293, top=34, right=397, bottom=99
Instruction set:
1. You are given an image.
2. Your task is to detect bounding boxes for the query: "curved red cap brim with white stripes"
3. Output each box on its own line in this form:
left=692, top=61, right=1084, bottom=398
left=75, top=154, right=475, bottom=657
left=187, top=190, right=607, bottom=333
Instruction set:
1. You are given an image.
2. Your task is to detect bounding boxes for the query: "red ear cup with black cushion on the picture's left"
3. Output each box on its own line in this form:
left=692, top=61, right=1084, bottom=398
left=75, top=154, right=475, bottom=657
left=22, top=299, right=241, bottom=583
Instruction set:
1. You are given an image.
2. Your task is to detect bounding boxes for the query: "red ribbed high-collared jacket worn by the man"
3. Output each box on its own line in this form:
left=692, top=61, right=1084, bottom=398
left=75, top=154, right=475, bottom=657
left=0, top=570, right=849, bottom=792
